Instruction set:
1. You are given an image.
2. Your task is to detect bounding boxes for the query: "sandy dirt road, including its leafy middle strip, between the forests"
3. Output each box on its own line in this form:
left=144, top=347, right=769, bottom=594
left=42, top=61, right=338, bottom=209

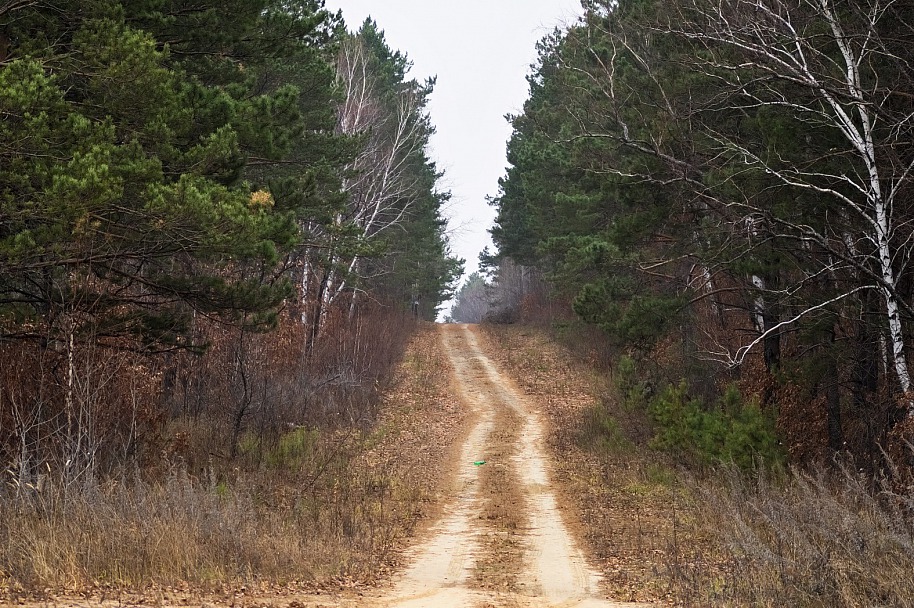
left=360, top=325, right=635, bottom=608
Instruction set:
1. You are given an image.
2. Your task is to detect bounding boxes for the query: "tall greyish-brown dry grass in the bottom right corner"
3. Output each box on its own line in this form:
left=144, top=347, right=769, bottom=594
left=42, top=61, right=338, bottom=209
left=669, top=467, right=914, bottom=608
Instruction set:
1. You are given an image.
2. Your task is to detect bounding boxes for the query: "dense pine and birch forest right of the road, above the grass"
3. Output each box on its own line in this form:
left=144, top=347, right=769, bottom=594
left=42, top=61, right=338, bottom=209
left=482, top=0, right=914, bottom=469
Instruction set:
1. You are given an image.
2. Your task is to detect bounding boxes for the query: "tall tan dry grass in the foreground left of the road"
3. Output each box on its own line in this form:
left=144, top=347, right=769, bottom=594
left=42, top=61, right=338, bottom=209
left=0, top=438, right=422, bottom=591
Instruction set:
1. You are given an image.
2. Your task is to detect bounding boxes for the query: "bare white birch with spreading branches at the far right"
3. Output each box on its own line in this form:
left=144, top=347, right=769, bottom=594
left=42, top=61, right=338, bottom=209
left=661, top=0, right=914, bottom=400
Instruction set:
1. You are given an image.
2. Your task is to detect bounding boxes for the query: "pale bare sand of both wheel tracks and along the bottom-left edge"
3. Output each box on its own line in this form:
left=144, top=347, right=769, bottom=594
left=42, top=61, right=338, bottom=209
left=19, top=325, right=647, bottom=608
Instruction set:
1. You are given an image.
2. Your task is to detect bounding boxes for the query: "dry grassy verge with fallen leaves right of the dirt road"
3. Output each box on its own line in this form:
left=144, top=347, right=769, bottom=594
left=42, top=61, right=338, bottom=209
left=485, top=326, right=914, bottom=608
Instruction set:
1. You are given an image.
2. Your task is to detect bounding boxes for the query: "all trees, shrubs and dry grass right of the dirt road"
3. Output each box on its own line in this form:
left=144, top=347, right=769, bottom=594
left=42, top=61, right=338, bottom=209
left=474, top=0, right=914, bottom=607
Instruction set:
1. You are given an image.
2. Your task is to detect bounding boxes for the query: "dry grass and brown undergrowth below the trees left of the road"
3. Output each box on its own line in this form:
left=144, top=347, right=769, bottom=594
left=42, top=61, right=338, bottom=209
left=0, top=305, right=428, bottom=592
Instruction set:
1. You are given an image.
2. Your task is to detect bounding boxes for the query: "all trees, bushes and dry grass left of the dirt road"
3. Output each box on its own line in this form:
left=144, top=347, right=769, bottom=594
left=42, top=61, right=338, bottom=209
left=0, top=0, right=461, bottom=600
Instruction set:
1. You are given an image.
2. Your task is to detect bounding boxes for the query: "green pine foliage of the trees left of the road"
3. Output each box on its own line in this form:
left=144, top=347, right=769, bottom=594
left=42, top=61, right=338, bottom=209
left=0, top=0, right=457, bottom=349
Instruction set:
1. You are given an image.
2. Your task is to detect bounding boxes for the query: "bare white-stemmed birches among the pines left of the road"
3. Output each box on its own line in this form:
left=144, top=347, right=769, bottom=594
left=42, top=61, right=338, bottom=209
left=306, top=21, right=446, bottom=343
